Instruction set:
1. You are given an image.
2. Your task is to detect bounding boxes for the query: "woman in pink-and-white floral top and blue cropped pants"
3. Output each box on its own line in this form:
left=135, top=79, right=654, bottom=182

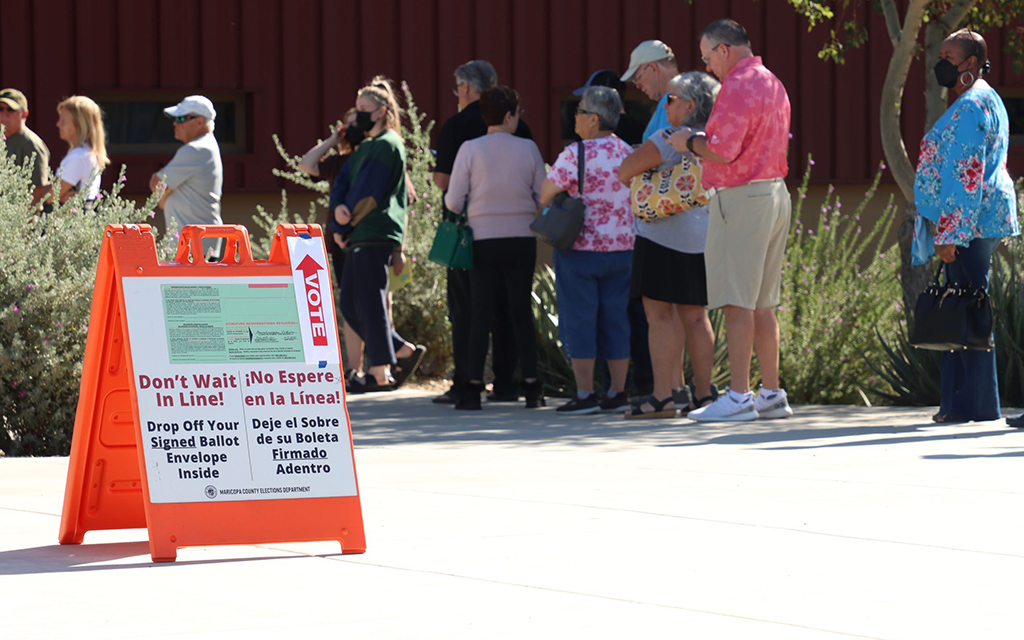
left=541, top=87, right=635, bottom=414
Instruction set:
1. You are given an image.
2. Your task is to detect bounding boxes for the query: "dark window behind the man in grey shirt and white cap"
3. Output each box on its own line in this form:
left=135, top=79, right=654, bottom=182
left=93, top=91, right=248, bottom=155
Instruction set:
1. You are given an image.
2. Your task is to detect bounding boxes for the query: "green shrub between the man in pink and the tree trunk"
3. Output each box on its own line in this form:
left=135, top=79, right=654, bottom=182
left=777, top=159, right=901, bottom=403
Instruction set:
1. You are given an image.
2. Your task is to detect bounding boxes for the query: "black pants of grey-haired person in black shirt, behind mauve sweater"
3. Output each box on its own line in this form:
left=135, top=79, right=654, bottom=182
left=447, top=264, right=520, bottom=394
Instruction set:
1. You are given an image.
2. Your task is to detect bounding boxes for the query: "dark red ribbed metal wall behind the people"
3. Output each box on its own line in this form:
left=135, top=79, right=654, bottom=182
left=0, top=0, right=1024, bottom=191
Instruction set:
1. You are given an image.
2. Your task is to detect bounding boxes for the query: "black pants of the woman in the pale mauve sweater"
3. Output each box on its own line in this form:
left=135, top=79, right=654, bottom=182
left=469, top=238, right=537, bottom=381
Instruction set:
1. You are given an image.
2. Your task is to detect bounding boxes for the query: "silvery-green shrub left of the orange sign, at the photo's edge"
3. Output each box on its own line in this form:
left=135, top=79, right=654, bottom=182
left=0, top=133, right=163, bottom=456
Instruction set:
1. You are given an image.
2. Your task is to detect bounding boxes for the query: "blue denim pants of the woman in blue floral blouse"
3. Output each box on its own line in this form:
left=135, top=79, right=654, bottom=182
left=939, top=238, right=1000, bottom=420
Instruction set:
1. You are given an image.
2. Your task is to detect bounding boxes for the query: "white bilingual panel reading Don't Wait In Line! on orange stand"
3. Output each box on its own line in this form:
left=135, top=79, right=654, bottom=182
left=122, top=276, right=356, bottom=503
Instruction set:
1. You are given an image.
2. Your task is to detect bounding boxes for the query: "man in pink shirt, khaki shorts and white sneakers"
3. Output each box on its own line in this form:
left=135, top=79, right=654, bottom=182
left=670, top=19, right=793, bottom=422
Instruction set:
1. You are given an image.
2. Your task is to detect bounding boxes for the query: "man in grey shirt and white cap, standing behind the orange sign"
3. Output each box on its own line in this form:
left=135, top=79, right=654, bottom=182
left=150, top=95, right=224, bottom=259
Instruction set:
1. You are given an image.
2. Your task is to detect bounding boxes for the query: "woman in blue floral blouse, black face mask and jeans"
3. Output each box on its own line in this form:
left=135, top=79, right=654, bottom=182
left=913, top=29, right=1020, bottom=422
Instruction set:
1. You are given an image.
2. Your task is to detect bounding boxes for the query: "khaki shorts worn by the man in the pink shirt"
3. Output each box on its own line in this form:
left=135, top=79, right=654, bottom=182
left=705, top=178, right=793, bottom=309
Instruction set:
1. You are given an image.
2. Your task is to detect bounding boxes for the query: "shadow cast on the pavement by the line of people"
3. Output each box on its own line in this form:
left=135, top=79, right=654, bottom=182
left=348, top=393, right=991, bottom=450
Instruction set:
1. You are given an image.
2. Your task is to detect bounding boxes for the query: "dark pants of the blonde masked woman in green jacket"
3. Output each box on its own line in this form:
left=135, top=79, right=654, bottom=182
left=340, top=245, right=406, bottom=367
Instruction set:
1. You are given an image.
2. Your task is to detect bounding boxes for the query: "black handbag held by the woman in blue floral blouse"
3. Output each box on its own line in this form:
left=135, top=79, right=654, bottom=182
left=910, top=262, right=994, bottom=351
